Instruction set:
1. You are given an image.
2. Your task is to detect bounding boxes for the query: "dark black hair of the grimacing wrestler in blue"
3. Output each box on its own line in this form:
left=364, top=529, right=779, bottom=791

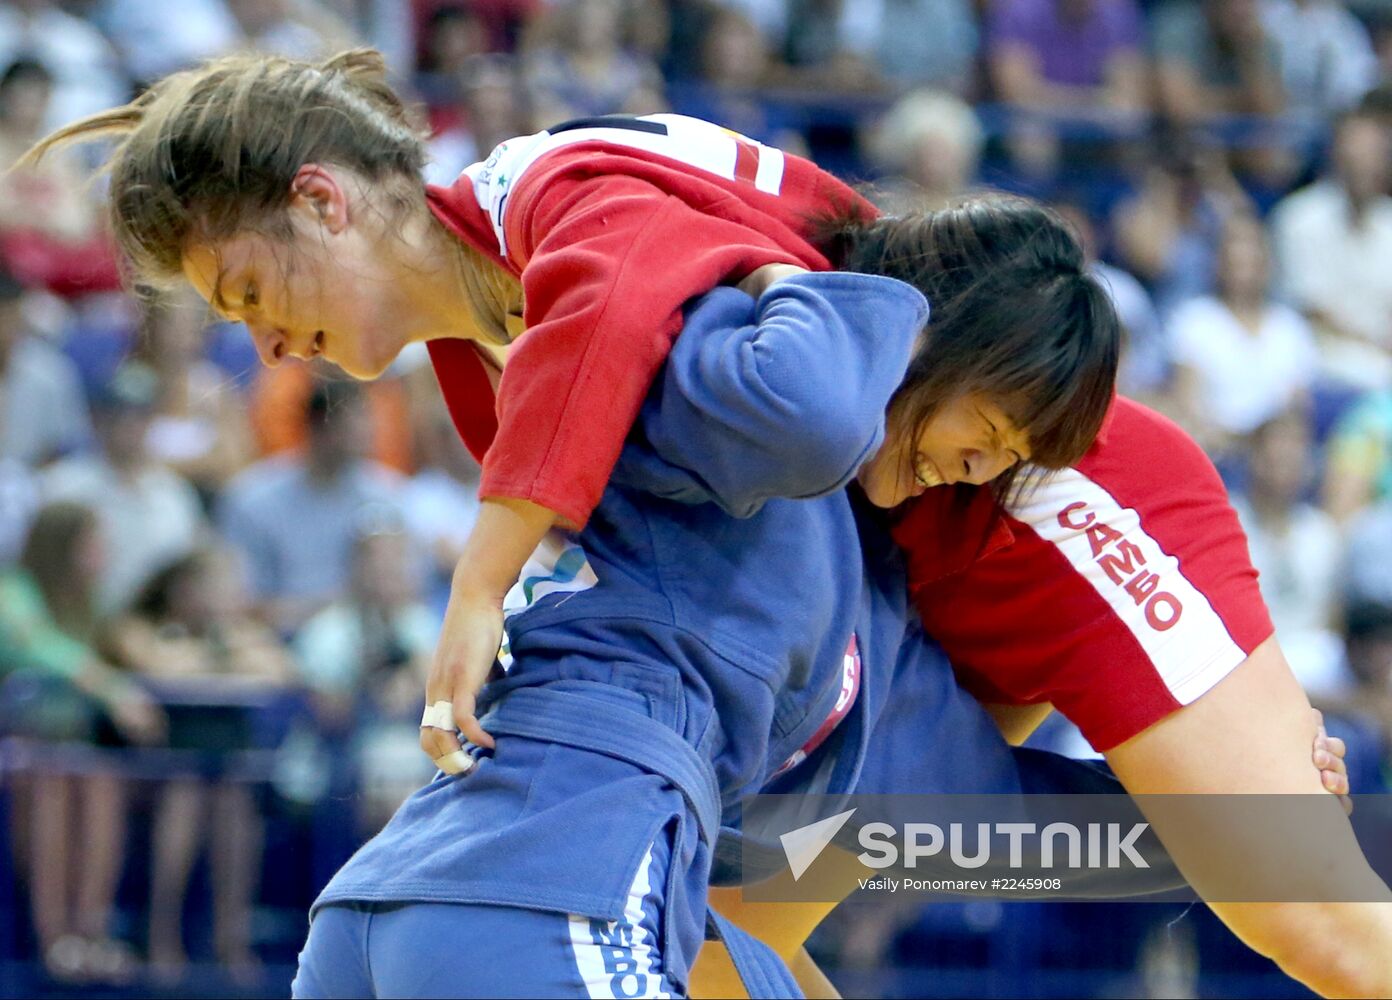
left=827, top=195, right=1122, bottom=497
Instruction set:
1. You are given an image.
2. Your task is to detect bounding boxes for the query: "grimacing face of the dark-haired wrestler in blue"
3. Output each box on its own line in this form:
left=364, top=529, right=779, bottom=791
left=856, top=393, right=1030, bottom=507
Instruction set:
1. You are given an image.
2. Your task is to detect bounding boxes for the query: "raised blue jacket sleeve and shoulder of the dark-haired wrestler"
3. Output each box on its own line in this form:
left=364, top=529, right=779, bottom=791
left=615, top=272, right=928, bottom=517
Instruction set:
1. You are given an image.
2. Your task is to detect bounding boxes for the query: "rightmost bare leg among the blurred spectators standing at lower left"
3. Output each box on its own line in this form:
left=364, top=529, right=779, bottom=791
left=212, top=784, right=266, bottom=981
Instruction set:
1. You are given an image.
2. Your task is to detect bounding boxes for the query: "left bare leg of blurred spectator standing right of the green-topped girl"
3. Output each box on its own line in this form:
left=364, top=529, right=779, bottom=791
left=150, top=779, right=205, bottom=979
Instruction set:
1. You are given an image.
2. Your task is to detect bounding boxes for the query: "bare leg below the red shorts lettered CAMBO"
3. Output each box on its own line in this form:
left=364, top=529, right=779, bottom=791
left=1107, top=639, right=1392, bottom=996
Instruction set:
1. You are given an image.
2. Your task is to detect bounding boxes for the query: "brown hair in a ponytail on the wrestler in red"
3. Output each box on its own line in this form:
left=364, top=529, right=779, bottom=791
left=21, top=49, right=426, bottom=288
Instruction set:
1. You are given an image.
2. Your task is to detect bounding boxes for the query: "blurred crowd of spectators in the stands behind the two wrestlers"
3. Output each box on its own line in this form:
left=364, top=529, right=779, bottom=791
left=0, top=0, right=1392, bottom=990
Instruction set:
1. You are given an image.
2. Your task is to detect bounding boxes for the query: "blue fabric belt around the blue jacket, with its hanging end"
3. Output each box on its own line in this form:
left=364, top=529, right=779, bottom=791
left=482, top=688, right=802, bottom=1000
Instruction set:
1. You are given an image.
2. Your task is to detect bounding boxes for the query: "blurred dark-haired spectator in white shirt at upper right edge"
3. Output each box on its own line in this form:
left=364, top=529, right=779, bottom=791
left=1272, top=111, right=1392, bottom=389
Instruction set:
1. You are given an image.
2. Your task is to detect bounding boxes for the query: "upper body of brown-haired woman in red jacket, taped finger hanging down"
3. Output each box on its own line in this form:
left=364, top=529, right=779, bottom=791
left=31, top=50, right=913, bottom=769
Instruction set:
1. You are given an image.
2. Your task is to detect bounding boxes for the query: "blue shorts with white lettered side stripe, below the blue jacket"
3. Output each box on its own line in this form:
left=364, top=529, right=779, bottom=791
left=291, top=834, right=679, bottom=1000
